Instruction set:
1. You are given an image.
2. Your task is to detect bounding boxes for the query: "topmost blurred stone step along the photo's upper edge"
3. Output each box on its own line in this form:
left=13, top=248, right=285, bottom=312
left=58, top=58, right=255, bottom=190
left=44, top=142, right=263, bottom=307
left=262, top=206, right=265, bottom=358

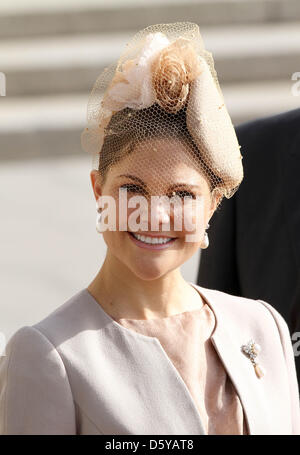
left=0, top=0, right=300, bottom=39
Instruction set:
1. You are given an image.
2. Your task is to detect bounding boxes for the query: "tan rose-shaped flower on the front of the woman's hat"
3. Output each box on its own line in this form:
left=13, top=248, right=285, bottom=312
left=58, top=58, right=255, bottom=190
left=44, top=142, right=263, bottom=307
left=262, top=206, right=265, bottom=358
left=152, top=38, right=201, bottom=113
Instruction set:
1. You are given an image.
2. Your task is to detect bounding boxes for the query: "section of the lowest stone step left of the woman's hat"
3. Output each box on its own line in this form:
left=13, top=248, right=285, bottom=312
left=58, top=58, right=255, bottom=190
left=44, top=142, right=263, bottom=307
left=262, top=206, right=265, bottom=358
left=0, top=94, right=88, bottom=160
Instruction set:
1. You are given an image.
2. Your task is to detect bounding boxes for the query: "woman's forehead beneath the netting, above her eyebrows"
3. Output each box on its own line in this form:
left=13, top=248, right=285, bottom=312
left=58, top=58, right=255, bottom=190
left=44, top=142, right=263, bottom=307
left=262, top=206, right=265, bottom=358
left=106, top=138, right=208, bottom=190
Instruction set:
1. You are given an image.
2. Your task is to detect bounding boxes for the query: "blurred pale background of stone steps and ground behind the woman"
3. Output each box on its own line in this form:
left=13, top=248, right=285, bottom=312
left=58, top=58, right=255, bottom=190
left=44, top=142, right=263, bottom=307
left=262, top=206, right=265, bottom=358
left=0, top=0, right=300, bottom=349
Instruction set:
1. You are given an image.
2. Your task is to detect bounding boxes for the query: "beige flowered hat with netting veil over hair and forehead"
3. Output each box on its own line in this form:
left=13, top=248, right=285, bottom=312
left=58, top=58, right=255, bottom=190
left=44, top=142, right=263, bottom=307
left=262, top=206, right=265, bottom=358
left=81, top=22, right=243, bottom=223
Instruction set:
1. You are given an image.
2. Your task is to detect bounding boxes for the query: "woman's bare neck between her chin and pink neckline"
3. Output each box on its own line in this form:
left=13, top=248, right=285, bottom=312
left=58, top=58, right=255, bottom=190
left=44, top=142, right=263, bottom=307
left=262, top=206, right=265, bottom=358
left=87, top=253, right=203, bottom=319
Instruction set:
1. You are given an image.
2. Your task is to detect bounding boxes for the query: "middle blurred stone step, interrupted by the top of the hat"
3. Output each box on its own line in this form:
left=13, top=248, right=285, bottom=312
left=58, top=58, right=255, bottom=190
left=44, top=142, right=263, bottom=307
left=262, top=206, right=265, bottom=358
left=0, top=22, right=300, bottom=97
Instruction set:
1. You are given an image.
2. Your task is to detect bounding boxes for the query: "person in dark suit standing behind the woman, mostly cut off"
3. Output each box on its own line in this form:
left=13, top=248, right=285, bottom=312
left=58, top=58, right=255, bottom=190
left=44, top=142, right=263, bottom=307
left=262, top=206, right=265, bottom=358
left=197, top=109, right=300, bottom=388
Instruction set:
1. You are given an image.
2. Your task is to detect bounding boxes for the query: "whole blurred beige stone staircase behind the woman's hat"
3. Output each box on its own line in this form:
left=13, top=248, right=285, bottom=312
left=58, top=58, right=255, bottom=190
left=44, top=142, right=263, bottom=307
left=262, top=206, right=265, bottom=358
left=0, top=0, right=300, bottom=160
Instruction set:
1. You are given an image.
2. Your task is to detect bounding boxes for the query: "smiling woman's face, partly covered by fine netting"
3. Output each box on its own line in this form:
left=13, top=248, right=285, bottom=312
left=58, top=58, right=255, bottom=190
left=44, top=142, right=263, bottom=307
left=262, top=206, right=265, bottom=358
left=91, top=139, right=217, bottom=280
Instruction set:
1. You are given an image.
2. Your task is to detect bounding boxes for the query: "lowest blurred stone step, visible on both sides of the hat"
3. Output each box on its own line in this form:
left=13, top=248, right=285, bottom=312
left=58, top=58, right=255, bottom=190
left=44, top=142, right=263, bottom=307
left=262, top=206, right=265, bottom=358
left=0, top=80, right=300, bottom=160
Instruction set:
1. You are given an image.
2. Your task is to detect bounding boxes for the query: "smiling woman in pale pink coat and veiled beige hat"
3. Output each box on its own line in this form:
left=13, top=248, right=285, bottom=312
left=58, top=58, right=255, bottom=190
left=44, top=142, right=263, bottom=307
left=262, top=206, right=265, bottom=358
left=0, top=23, right=300, bottom=435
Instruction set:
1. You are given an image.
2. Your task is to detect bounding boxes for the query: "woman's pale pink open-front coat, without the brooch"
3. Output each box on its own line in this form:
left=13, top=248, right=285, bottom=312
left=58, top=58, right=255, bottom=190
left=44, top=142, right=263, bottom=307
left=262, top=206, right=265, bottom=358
left=0, top=283, right=300, bottom=435
